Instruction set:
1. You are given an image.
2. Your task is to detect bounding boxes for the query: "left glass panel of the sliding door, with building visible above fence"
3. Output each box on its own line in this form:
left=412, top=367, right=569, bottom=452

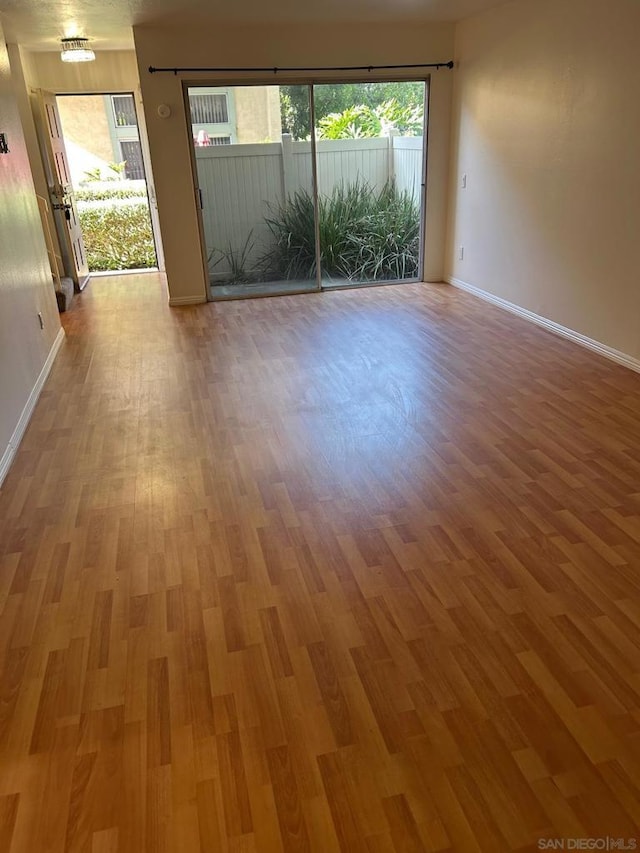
left=188, top=86, right=318, bottom=299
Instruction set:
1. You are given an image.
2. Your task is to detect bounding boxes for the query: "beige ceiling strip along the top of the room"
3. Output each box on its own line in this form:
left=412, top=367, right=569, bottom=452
left=0, top=0, right=504, bottom=50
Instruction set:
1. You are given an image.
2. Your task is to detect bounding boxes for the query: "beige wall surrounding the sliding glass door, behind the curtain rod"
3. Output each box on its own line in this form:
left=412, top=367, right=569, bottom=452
left=134, top=23, right=454, bottom=304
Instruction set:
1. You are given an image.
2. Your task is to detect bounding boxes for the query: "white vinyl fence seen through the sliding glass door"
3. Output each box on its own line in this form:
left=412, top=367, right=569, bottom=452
left=195, top=134, right=423, bottom=278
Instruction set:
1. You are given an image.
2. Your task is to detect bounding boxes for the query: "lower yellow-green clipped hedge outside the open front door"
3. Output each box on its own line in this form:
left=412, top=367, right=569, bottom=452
left=78, top=204, right=157, bottom=272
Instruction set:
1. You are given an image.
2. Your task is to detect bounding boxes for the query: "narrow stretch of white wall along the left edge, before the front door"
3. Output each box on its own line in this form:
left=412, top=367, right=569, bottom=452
left=0, top=25, right=60, bottom=482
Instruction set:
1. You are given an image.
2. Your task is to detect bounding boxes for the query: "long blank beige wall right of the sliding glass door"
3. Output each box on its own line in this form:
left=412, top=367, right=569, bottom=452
left=447, top=0, right=640, bottom=358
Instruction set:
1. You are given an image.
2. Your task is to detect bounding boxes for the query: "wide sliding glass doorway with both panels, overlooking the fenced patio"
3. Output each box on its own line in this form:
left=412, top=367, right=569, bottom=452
left=185, top=80, right=427, bottom=299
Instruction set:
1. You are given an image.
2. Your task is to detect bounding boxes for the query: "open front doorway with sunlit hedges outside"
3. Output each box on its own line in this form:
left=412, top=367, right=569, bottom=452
left=56, top=92, right=158, bottom=274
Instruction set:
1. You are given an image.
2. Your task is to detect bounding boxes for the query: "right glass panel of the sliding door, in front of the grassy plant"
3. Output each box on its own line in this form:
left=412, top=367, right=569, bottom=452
left=313, top=81, right=426, bottom=287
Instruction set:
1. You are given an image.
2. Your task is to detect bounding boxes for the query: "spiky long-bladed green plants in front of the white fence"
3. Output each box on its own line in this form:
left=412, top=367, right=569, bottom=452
left=261, top=181, right=420, bottom=281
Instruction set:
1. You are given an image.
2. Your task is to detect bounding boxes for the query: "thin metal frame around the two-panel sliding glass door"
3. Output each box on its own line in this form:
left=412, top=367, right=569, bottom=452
left=181, top=72, right=432, bottom=302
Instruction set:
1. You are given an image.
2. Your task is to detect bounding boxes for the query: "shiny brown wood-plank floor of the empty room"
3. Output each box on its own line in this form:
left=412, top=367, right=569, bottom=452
left=0, top=275, right=640, bottom=853
